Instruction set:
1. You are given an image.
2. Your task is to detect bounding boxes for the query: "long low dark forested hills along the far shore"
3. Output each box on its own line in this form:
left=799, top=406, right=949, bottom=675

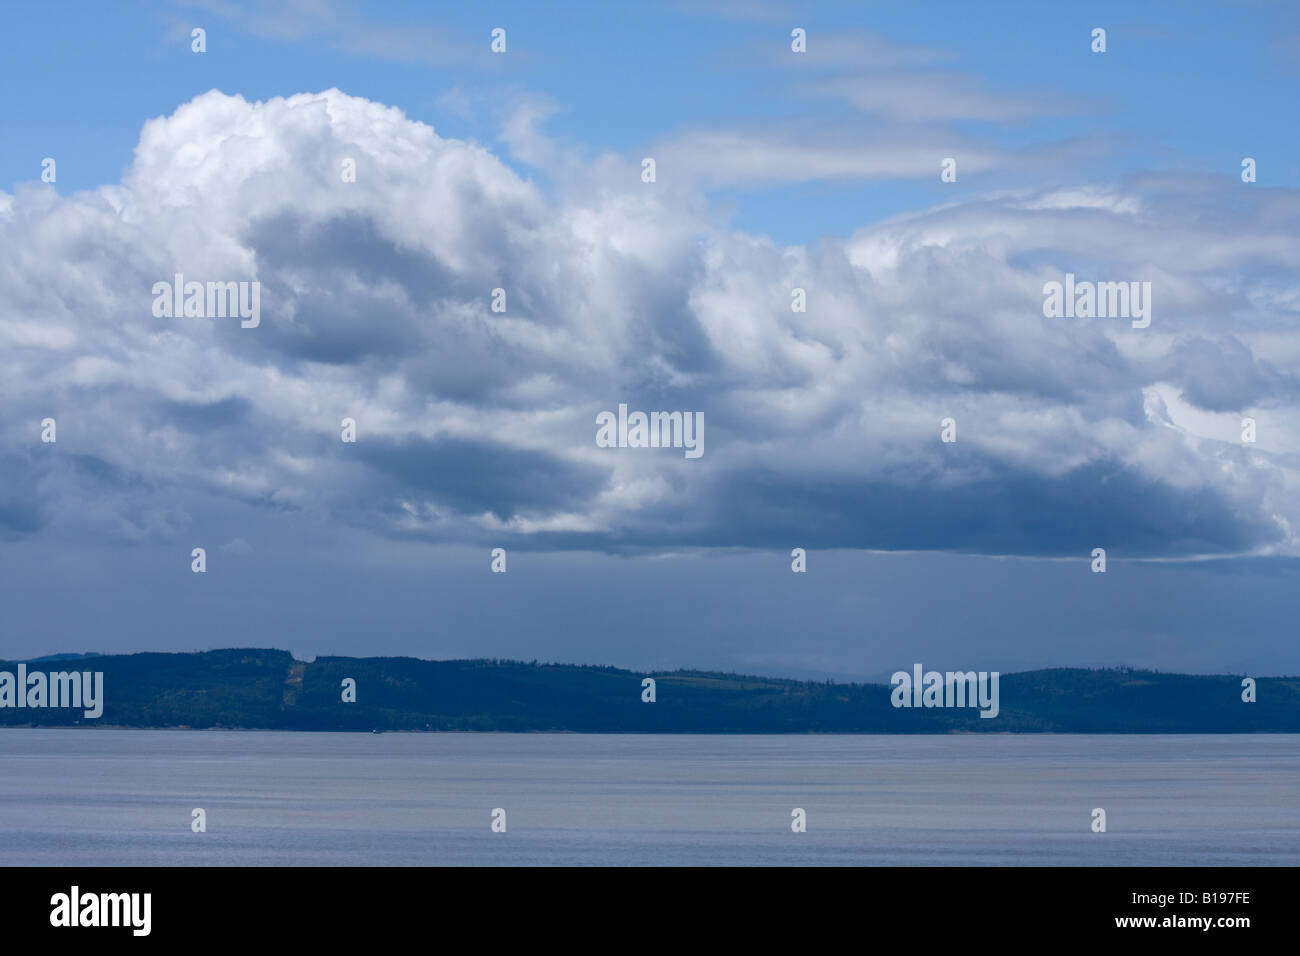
left=0, top=649, right=1300, bottom=734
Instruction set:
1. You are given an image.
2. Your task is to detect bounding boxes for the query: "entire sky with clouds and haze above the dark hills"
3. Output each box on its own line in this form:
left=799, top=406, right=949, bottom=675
left=0, top=0, right=1300, bottom=678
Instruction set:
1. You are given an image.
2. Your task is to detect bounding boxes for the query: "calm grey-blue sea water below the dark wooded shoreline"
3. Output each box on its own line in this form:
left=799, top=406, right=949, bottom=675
left=0, top=728, right=1300, bottom=866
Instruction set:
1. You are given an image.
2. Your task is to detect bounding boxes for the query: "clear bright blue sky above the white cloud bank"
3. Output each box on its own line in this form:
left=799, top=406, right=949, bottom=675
left=0, top=3, right=1300, bottom=242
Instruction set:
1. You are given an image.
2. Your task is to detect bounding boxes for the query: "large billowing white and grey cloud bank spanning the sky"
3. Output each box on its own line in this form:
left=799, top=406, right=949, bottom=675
left=0, top=90, right=1300, bottom=557
